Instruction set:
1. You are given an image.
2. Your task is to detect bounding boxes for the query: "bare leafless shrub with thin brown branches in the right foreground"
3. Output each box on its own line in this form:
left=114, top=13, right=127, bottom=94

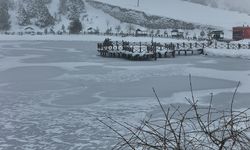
left=98, top=75, right=250, bottom=150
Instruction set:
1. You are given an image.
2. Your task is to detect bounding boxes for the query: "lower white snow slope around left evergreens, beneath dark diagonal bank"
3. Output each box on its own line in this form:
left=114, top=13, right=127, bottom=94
left=9, top=0, right=143, bottom=32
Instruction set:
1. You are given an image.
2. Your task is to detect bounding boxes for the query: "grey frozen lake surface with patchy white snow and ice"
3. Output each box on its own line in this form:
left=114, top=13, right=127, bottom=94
left=0, top=41, right=250, bottom=150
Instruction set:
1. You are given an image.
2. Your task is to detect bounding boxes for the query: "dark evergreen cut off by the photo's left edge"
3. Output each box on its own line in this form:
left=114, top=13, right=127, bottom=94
left=0, top=0, right=11, bottom=30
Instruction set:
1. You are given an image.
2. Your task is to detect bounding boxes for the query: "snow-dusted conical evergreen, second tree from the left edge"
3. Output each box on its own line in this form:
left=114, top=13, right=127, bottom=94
left=17, top=3, right=30, bottom=26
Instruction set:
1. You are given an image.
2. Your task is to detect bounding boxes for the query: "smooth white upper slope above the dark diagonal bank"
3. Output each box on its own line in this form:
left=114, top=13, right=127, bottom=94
left=96, top=0, right=250, bottom=29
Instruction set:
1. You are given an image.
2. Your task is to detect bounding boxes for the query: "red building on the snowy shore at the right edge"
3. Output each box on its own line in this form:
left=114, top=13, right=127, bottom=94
left=233, top=26, right=250, bottom=41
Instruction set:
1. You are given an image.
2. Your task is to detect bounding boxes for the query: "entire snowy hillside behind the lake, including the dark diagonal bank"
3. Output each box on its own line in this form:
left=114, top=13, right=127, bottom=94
left=2, top=0, right=250, bottom=32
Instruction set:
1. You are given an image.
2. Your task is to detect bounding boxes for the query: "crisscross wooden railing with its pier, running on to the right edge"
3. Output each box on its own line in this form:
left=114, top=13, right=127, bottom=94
left=97, top=41, right=250, bottom=60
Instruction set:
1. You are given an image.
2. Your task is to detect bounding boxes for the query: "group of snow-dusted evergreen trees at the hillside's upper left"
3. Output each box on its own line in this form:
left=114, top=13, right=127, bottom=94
left=0, top=0, right=86, bottom=34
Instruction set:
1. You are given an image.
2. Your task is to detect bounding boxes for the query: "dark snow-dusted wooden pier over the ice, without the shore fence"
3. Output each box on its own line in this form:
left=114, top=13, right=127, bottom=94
left=97, top=41, right=205, bottom=60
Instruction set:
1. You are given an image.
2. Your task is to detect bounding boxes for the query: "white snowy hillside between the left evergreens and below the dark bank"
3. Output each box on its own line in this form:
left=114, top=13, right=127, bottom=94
left=6, top=0, right=145, bottom=32
